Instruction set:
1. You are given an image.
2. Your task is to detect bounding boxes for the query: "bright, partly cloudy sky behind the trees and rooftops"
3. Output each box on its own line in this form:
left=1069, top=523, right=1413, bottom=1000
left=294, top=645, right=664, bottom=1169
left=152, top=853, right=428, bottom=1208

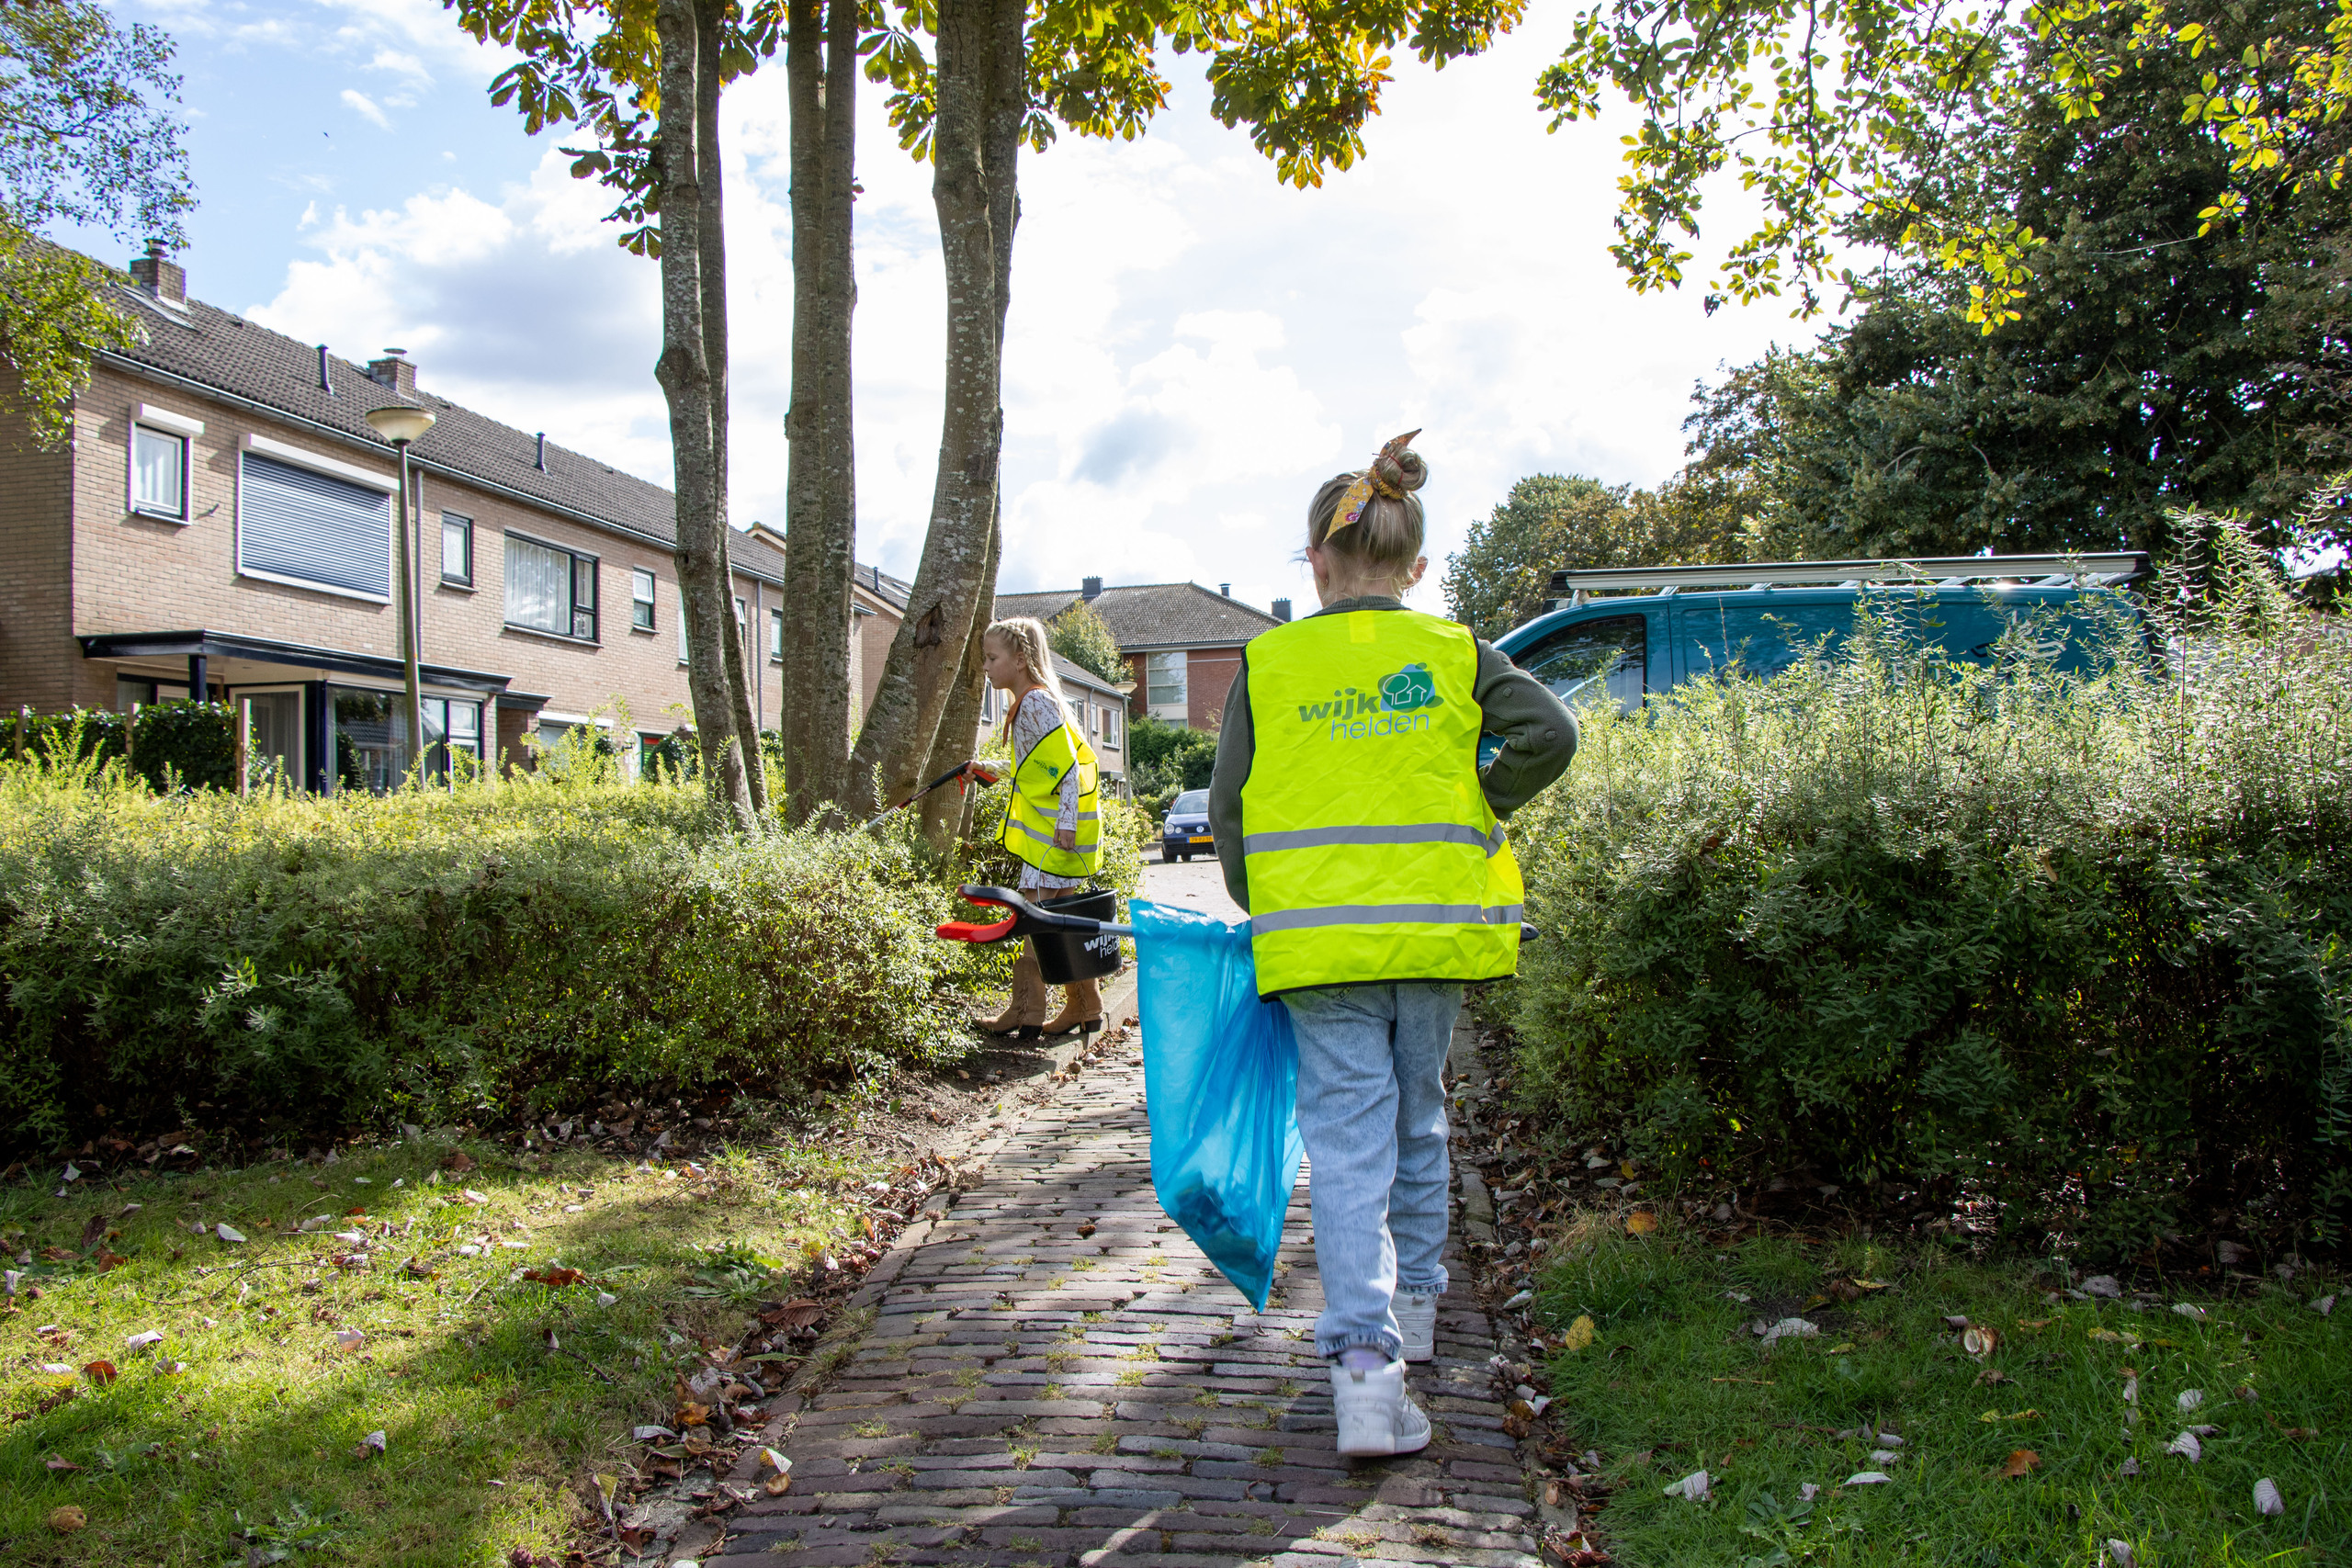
left=83, top=0, right=1814, bottom=609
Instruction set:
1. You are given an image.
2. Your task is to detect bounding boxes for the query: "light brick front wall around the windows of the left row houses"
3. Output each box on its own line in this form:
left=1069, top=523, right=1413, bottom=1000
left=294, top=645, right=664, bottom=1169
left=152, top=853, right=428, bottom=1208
left=55, top=369, right=781, bottom=733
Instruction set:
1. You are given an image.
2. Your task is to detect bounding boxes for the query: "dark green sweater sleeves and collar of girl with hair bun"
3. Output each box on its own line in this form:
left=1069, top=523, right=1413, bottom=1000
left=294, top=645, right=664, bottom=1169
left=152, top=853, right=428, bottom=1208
left=1209, top=600, right=1576, bottom=909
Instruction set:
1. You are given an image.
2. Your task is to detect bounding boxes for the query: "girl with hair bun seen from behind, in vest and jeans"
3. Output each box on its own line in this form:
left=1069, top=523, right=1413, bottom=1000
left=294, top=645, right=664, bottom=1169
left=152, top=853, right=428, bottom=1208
left=1209, top=430, right=1576, bottom=1455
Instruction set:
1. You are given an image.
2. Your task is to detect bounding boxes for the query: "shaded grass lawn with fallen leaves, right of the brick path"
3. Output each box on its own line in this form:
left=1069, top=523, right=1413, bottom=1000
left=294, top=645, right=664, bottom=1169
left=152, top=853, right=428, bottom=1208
left=1536, top=1215, right=2352, bottom=1568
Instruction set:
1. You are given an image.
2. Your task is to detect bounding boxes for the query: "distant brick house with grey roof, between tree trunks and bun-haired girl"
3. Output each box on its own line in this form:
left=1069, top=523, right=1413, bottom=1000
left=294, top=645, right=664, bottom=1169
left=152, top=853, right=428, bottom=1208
left=997, top=576, right=1291, bottom=728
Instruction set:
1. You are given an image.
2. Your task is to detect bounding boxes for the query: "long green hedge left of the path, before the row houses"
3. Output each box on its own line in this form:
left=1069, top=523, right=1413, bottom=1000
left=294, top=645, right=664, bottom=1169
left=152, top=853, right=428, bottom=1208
left=0, top=764, right=971, bottom=1152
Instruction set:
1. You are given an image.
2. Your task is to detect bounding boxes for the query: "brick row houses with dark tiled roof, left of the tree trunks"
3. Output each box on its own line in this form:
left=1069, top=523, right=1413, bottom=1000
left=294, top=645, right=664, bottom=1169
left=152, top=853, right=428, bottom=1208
left=0, top=254, right=864, bottom=790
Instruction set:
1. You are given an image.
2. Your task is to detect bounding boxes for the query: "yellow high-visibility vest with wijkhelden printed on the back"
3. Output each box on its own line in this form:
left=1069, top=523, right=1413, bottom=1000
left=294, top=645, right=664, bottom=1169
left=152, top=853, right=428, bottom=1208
left=1242, top=609, right=1524, bottom=997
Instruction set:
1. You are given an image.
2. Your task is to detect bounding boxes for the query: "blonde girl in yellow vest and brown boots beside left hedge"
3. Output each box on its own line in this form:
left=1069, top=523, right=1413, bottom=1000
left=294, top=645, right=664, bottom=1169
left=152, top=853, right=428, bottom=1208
left=981, top=616, right=1103, bottom=1039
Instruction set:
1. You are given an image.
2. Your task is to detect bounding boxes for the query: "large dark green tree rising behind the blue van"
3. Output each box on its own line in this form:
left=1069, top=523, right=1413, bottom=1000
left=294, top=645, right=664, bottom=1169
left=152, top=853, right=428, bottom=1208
left=1689, top=17, right=2352, bottom=570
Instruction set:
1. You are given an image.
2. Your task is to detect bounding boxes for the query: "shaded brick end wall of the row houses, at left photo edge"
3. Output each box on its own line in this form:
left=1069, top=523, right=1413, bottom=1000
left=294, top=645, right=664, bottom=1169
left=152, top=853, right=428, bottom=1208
left=0, top=365, right=83, bottom=712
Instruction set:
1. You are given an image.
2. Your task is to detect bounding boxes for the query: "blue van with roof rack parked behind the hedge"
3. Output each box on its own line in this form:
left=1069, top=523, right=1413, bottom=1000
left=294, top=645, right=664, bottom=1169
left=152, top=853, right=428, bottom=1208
left=1496, top=552, right=2147, bottom=710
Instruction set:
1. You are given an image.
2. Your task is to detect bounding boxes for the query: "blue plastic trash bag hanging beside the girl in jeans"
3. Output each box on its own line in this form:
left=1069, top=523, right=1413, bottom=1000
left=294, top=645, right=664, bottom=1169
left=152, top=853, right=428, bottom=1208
left=1126, top=900, right=1306, bottom=1312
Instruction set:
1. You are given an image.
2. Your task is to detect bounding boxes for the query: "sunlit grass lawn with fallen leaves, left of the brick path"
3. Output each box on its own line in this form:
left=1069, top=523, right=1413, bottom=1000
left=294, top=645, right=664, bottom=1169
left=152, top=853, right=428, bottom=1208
left=0, top=1135, right=899, bottom=1565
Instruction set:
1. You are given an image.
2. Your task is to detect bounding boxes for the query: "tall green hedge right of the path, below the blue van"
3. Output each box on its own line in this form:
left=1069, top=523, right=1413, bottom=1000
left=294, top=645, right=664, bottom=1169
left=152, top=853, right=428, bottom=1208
left=1494, top=534, right=2352, bottom=1256
